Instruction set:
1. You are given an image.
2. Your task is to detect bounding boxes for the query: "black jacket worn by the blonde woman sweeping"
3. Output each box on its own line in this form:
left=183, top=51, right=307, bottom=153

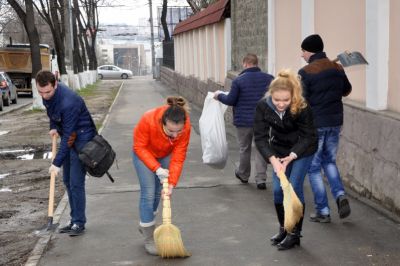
left=254, top=97, right=318, bottom=160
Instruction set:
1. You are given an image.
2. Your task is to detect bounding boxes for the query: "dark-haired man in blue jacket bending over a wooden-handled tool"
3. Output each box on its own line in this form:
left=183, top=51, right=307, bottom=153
left=36, top=71, right=97, bottom=236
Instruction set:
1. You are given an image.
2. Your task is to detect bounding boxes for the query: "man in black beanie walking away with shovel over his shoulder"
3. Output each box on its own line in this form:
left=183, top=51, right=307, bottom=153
left=299, top=34, right=352, bottom=223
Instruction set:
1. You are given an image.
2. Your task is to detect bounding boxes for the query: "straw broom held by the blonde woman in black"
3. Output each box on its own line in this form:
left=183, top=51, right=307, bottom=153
left=278, top=171, right=303, bottom=232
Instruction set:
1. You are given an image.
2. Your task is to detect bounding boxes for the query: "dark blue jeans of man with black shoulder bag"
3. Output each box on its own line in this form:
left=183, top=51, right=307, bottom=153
left=63, top=141, right=87, bottom=226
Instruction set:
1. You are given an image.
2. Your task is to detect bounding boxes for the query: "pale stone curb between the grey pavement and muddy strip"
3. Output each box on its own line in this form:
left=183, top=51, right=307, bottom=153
left=23, top=82, right=124, bottom=266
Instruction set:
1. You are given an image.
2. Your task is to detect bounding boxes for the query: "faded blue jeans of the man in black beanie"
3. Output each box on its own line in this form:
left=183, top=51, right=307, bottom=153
left=308, top=126, right=344, bottom=215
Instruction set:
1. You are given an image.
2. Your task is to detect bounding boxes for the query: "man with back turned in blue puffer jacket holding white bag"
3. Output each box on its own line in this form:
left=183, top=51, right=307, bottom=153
left=214, top=53, right=274, bottom=189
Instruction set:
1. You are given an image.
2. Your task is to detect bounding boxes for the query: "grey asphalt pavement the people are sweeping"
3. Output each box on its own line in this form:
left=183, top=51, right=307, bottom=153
left=35, top=77, right=400, bottom=266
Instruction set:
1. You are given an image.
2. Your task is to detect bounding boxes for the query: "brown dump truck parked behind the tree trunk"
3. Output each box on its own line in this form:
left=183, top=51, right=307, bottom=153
left=0, top=44, right=52, bottom=95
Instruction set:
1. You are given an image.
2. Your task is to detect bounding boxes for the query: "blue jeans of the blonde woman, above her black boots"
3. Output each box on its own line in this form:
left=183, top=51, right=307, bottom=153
left=272, top=155, right=313, bottom=204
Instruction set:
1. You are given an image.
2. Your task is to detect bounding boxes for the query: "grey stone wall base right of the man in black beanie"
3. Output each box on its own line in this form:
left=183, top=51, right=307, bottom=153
left=337, top=101, right=400, bottom=215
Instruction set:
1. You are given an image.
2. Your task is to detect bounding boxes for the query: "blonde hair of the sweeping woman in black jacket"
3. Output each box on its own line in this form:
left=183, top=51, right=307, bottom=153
left=267, top=69, right=307, bottom=115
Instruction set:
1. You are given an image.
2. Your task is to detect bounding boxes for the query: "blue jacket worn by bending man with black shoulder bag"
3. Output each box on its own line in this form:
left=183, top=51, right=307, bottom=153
left=43, top=83, right=96, bottom=167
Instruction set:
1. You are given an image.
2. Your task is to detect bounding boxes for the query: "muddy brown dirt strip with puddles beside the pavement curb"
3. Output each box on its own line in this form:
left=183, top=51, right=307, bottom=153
left=0, top=81, right=121, bottom=265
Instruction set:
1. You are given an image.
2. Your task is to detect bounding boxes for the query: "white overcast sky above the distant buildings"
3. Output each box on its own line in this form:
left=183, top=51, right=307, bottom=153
left=99, top=0, right=188, bottom=25
